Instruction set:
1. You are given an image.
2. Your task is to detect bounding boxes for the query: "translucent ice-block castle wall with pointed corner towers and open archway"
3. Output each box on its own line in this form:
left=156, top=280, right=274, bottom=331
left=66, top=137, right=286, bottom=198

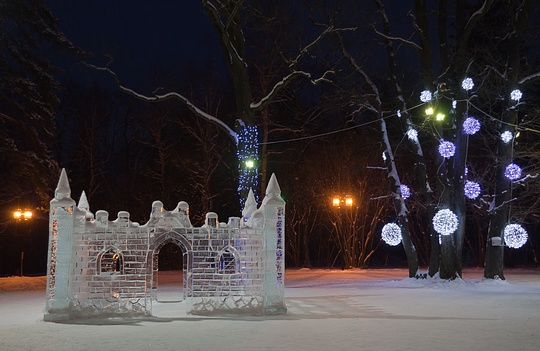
left=45, top=170, right=286, bottom=321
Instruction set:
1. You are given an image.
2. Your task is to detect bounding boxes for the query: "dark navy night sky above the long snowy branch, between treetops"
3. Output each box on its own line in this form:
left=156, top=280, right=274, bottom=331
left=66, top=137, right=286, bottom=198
left=48, top=0, right=219, bottom=86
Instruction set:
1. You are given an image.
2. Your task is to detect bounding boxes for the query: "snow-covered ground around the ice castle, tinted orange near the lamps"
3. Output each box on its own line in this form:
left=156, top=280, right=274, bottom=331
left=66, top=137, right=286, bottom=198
left=0, top=269, right=540, bottom=351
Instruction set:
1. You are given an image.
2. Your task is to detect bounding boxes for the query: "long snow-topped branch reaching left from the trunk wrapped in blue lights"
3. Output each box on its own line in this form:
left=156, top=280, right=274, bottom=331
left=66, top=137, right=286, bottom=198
left=84, top=63, right=238, bottom=143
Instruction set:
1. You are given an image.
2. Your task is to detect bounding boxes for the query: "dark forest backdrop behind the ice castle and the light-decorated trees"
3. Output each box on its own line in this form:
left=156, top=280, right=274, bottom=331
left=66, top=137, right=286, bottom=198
left=0, top=0, right=540, bottom=275
